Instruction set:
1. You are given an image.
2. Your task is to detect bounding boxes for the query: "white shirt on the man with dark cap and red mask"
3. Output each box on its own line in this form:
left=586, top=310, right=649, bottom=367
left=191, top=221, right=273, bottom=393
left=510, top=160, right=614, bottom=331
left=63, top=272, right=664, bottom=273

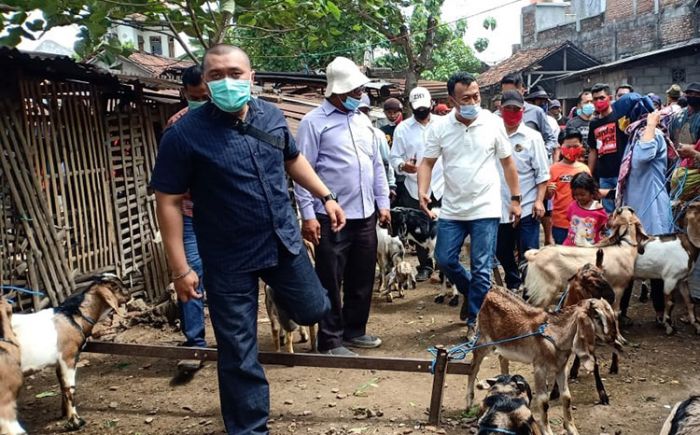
left=498, top=123, right=553, bottom=224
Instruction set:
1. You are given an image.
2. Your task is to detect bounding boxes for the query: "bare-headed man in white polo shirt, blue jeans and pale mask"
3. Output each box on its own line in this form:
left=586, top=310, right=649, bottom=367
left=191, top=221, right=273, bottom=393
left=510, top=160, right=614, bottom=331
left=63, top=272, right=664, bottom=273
left=418, top=72, right=522, bottom=339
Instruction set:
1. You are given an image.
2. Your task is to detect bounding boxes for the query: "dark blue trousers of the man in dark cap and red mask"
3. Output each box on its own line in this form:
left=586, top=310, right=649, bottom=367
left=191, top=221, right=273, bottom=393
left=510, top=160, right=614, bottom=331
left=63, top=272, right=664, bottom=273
left=496, top=215, right=540, bottom=289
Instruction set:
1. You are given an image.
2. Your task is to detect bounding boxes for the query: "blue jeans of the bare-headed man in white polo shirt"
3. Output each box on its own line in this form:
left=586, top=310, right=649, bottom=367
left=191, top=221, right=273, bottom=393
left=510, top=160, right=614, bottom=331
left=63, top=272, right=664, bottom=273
left=435, top=218, right=498, bottom=325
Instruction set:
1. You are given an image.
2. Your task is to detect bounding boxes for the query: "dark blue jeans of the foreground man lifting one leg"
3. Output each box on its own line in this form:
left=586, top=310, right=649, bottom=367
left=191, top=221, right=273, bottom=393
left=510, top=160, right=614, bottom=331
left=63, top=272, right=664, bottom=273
left=203, top=245, right=330, bottom=435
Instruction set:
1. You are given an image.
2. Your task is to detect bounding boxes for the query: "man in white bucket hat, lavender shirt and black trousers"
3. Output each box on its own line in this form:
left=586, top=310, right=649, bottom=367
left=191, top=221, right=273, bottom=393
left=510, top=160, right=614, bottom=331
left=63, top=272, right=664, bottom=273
left=296, top=57, right=391, bottom=356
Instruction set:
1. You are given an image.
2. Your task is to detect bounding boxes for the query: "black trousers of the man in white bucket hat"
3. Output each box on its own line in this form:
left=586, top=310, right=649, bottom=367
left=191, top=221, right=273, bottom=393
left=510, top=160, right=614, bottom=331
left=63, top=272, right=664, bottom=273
left=316, top=214, right=377, bottom=352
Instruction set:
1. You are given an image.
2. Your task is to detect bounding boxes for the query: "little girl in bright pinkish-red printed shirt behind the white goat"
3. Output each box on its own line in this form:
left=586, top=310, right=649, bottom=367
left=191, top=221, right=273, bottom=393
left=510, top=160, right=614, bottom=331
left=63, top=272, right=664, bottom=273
left=564, top=172, right=608, bottom=246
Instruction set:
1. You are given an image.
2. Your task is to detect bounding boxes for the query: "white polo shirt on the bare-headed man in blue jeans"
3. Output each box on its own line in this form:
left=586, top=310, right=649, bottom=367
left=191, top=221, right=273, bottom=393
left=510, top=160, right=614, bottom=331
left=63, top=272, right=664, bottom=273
left=423, top=109, right=512, bottom=221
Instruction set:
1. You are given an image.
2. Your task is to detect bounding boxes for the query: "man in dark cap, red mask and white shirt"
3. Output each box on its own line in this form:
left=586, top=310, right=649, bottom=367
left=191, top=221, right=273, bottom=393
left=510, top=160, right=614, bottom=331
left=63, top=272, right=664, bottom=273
left=496, top=91, right=549, bottom=290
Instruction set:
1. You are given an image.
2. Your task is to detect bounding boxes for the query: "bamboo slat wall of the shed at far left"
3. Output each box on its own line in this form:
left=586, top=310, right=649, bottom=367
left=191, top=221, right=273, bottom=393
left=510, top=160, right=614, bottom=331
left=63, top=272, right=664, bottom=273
left=0, top=76, right=173, bottom=310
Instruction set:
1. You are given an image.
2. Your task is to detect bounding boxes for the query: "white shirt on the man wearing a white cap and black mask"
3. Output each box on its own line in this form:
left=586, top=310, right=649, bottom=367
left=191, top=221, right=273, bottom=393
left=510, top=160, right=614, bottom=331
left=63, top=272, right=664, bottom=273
left=391, top=114, right=445, bottom=200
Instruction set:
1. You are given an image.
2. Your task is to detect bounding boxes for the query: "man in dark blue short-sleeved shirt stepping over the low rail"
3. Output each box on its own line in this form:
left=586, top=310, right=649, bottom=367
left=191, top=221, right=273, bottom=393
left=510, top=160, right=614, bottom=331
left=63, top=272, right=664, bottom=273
left=151, top=45, right=345, bottom=435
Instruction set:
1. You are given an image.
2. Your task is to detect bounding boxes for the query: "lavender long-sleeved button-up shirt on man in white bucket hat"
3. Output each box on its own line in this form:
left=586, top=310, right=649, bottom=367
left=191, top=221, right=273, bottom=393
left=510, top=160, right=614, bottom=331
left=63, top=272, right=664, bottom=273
left=295, top=100, right=389, bottom=220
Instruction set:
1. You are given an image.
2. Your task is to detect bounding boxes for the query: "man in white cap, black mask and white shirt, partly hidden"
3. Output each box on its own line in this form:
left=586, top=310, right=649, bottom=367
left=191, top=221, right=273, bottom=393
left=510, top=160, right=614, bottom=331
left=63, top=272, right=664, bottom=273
left=391, top=87, right=445, bottom=281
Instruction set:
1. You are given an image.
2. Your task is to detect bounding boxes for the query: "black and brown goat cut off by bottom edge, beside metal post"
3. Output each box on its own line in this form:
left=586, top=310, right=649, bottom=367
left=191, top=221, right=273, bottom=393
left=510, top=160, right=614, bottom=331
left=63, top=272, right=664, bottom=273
left=477, top=375, right=540, bottom=435
